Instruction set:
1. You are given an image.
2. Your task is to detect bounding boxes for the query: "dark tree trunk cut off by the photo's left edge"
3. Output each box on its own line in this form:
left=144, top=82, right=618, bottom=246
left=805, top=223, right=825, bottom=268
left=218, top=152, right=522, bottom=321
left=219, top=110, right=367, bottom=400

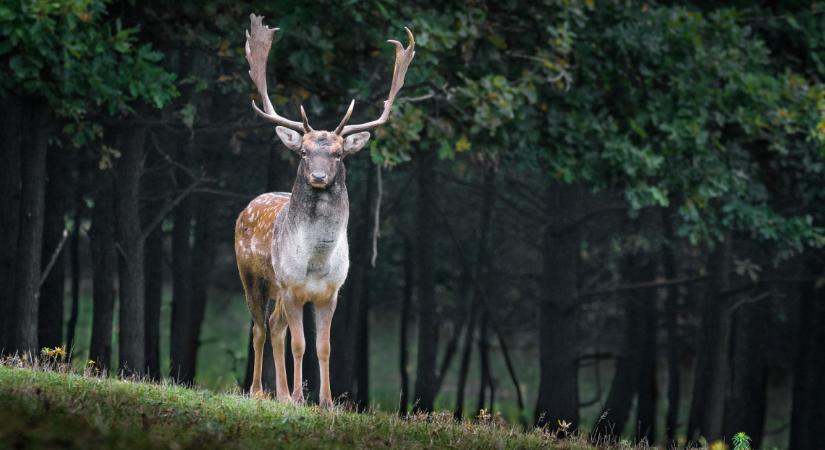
left=0, top=94, right=21, bottom=355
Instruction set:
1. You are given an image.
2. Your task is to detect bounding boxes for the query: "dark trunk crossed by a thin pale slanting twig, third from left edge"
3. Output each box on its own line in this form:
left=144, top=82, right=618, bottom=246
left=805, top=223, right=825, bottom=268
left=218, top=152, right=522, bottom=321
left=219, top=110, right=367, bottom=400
left=37, top=148, right=71, bottom=347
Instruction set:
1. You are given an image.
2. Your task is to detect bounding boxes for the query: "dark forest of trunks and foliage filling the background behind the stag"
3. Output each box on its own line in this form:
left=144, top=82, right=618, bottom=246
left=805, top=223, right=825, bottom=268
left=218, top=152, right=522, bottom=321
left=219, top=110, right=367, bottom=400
left=0, top=0, right=825, bottom=450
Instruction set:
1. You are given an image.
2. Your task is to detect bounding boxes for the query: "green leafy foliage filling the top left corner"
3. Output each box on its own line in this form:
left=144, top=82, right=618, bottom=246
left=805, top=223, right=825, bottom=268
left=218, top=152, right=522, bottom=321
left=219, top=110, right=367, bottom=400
left=0, top=0, right=177, bottom=144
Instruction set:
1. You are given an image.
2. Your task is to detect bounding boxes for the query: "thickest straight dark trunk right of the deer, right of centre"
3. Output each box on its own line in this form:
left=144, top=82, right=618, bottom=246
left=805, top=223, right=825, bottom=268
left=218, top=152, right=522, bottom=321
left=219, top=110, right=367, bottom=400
left=534, top=183, right=582, bottom=429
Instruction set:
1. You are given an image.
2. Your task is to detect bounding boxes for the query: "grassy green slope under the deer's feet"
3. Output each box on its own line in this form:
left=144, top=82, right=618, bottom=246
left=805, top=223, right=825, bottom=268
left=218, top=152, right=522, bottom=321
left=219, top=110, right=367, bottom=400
left=0, top=363, right=589, bottom=449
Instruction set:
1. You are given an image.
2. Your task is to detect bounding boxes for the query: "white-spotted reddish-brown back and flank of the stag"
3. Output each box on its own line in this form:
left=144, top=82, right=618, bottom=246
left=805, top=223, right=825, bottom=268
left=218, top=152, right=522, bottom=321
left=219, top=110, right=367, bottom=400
left=235, top=192, right=290, bottom=282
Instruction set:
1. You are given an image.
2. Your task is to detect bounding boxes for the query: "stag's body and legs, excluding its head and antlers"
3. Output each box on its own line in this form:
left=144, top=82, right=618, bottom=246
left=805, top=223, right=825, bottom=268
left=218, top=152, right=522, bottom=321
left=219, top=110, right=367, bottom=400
left=235, top=170, right=349, bottom=401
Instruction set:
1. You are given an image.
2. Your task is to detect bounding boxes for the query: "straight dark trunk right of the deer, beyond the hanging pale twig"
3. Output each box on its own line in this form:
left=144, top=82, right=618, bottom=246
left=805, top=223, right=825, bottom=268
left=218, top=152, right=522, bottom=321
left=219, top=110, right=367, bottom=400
left=413, top=151, right=437, bottom=412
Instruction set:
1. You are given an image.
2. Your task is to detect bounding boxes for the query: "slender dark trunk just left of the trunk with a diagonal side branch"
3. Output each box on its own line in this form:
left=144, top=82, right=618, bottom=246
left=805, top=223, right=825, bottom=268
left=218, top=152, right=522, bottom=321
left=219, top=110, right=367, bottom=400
left=89, top=162, right=117, bottom=370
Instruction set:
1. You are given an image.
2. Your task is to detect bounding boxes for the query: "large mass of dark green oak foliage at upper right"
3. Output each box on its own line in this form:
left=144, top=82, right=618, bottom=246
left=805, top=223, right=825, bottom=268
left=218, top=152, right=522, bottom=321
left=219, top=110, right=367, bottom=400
left=536, top=3, right=825, bottom=252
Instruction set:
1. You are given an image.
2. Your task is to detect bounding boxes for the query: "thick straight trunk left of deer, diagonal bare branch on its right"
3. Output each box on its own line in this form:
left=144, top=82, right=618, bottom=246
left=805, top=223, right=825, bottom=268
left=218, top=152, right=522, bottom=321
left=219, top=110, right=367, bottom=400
left=115, top=126, right=146, bottom=374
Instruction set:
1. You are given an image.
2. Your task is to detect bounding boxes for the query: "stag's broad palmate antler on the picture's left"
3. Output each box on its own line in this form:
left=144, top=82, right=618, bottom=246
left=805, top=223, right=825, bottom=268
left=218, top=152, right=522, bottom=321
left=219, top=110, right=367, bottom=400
left=245, top=14, right=309, bottom=132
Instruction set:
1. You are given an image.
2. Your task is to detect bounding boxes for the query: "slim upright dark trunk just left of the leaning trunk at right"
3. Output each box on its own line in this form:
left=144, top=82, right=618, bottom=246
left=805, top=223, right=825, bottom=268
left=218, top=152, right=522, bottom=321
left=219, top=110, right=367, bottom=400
left=662, top=209, right=681, bottom=446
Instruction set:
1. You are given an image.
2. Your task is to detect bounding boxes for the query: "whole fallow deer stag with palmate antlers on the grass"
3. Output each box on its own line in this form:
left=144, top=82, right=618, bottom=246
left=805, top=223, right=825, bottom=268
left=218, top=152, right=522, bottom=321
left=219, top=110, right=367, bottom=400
left=235, top=14, right=415, bottom=407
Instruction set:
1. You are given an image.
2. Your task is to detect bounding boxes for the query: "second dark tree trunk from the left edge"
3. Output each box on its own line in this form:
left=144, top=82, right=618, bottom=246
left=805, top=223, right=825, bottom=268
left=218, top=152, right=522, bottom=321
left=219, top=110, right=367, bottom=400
left=12, top=106, right=50, bottom=357
